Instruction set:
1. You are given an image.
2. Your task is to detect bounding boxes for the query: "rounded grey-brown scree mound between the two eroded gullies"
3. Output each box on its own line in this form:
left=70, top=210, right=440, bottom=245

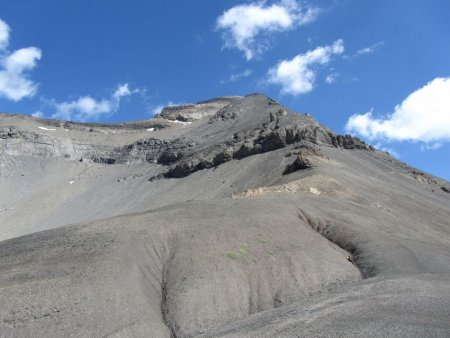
left=133, top=199, right=361, bottom=338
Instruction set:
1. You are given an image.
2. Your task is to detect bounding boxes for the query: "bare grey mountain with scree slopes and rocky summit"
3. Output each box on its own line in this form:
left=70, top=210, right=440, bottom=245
left=0, top=94, right=450, bottom=337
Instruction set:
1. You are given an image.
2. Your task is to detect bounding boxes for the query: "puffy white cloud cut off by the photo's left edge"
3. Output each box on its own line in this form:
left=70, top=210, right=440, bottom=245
left=0, top=20, right=42, bottom=101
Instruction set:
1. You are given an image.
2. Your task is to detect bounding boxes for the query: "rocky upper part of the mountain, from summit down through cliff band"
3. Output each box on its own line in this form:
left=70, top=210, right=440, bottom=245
left=0, top=94, right=373, bottom=178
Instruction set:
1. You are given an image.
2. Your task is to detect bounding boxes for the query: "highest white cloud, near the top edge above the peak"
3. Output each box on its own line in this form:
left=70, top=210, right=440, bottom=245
left=216, top=0, right=319, bottom=60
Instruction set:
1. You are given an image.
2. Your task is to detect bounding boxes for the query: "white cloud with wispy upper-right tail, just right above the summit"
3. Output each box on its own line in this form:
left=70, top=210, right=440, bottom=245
left=267, top=40, right=344, bottom=95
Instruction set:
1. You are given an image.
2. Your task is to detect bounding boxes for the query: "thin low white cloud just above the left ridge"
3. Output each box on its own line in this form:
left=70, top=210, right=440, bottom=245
left=52, top=84, right=134, bottom=121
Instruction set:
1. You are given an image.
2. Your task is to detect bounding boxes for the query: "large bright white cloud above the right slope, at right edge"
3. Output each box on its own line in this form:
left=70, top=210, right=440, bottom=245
left=346, top=78, right=450, bottom=145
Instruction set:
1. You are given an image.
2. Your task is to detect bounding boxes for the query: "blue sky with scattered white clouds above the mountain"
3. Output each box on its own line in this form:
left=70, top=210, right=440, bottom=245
left=0, top=0, right=450, bottom=180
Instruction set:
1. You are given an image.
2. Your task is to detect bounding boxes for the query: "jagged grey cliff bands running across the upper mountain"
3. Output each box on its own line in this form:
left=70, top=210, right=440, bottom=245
left=0, top=97, right=373, bottom=177
